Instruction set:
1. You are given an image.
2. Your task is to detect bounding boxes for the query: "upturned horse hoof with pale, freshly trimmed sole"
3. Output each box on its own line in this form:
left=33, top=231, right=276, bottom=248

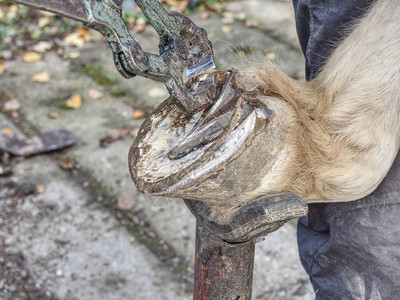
left=129, top=71, right=298, bottom=206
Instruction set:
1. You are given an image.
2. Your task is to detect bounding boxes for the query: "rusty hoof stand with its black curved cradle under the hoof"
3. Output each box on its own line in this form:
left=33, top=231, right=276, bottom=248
left=184, top=194, right=307, bottom=300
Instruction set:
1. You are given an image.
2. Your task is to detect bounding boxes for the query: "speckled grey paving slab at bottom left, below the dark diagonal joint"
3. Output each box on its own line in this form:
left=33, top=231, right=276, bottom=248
left=0, top=140, right=191, bottom=300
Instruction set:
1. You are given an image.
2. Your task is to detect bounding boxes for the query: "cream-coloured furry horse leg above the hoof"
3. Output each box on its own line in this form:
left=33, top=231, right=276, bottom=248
left=250, top=0, right=400, bottom=202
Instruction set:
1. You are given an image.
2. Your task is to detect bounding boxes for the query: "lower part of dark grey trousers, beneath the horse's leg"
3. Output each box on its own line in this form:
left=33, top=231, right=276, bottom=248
left=297, top=155, right=400, bottom=300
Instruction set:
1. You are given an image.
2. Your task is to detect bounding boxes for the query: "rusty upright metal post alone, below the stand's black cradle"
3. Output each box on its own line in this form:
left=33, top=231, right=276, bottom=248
left=193, top=221, right=255, bottom=300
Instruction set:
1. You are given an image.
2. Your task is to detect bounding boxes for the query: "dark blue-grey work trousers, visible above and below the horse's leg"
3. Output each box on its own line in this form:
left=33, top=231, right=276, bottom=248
left=293, top=0, right=400, bottom=300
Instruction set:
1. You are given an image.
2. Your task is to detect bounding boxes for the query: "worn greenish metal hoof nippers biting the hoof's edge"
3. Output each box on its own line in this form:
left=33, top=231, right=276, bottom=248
left=12, top=0, right=215, bottom=114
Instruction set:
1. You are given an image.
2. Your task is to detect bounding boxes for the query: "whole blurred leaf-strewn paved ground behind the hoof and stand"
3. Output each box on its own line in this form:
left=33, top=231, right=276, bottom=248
left=0, top=0, right=314, bottom=300
